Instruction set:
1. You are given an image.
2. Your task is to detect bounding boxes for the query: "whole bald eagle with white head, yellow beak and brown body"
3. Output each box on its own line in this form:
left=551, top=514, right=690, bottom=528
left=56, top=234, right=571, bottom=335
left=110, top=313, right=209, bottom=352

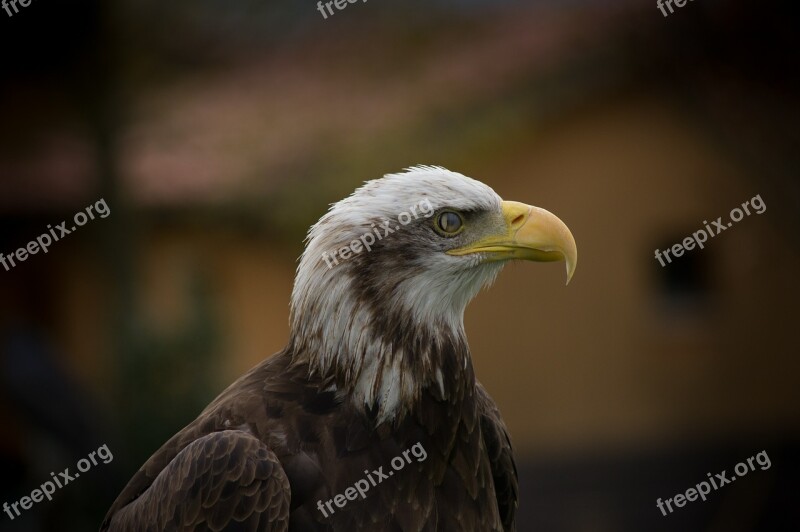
left=100, top=166, right=577, bottom=532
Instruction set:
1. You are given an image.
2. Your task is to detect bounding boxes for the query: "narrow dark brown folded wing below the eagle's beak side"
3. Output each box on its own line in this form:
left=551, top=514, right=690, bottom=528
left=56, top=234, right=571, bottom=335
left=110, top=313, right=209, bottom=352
left=476, top=383, right=519, bottom=532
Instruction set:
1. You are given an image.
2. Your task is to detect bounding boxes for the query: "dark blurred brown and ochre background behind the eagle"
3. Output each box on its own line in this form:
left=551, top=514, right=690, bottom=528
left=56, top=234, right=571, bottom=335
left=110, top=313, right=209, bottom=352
left=0, top=0, right=800, bottom=532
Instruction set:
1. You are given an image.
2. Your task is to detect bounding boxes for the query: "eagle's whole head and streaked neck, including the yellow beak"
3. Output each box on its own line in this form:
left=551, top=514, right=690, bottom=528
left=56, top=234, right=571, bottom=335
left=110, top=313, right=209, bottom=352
left=289, top=166, right=577, bottom=422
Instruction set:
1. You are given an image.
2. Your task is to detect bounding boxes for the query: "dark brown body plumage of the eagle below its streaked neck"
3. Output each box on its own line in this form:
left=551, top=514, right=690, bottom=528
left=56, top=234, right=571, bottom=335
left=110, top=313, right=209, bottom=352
left=101, top=352, right=517, bottom=532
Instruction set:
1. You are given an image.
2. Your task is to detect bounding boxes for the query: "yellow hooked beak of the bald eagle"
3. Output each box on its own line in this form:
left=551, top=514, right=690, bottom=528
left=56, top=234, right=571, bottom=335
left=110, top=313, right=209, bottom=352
left=447, top=201, right=578, bottom=284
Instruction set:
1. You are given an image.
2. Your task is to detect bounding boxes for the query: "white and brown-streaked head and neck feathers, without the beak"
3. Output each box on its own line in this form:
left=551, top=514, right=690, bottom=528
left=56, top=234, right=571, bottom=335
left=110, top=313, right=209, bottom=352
left=291, top=166, right=502, bottom=420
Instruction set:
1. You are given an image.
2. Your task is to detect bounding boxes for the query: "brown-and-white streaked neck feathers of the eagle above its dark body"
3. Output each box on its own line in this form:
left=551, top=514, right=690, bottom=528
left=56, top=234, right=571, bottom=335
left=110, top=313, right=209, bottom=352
left=289, top=284, right=475, bottom=423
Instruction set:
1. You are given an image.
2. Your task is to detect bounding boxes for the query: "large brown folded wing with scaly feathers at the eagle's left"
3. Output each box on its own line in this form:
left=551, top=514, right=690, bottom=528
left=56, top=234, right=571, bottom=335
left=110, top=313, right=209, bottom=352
left=100, top=426, right=291, bottom=532
